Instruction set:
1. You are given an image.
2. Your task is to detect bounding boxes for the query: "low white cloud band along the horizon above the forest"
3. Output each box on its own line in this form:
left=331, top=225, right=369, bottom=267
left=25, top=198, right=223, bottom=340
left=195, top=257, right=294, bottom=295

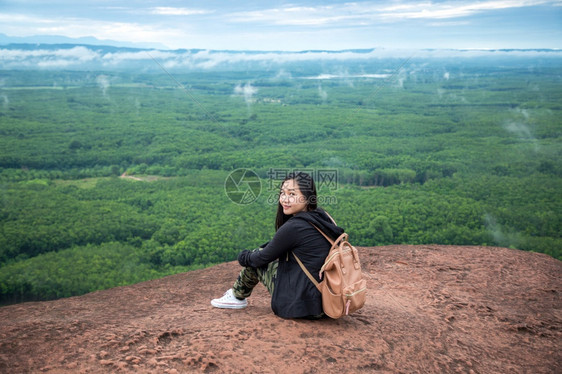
left=0, top=46, right=562, bottom=71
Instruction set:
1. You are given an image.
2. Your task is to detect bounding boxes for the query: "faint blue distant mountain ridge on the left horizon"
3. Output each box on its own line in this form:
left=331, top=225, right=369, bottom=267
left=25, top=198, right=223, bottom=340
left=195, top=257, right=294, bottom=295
left=0, top=33, right=169, bottom=49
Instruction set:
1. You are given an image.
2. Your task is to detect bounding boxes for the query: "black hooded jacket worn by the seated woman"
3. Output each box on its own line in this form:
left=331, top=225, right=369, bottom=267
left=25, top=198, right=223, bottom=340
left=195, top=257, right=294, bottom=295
left=238, top=209, right=344, bottom=318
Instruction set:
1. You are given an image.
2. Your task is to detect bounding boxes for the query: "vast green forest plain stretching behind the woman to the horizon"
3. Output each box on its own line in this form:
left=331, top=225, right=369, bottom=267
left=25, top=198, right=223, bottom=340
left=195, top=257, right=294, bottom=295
left=0, top=53, right=562, bottom=304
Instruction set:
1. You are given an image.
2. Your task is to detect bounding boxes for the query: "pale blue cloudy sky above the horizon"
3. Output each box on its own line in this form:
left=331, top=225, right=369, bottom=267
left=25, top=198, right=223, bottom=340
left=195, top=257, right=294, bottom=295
left=0, top=0, right=562, bottom=51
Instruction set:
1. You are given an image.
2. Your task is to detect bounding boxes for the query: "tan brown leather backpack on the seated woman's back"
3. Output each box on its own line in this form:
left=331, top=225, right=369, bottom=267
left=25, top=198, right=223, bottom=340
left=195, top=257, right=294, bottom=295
left=293, top=225, right=367, bottom=318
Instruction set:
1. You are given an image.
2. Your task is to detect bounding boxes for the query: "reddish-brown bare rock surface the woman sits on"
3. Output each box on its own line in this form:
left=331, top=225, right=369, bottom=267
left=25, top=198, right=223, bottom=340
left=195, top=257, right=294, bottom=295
left=0, top=245, right=562, bottom=374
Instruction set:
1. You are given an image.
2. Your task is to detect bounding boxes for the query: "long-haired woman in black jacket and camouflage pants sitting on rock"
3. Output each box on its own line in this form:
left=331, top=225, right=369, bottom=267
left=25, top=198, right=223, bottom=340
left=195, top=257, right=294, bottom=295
left=211, top=173, right=344, bottom=318
